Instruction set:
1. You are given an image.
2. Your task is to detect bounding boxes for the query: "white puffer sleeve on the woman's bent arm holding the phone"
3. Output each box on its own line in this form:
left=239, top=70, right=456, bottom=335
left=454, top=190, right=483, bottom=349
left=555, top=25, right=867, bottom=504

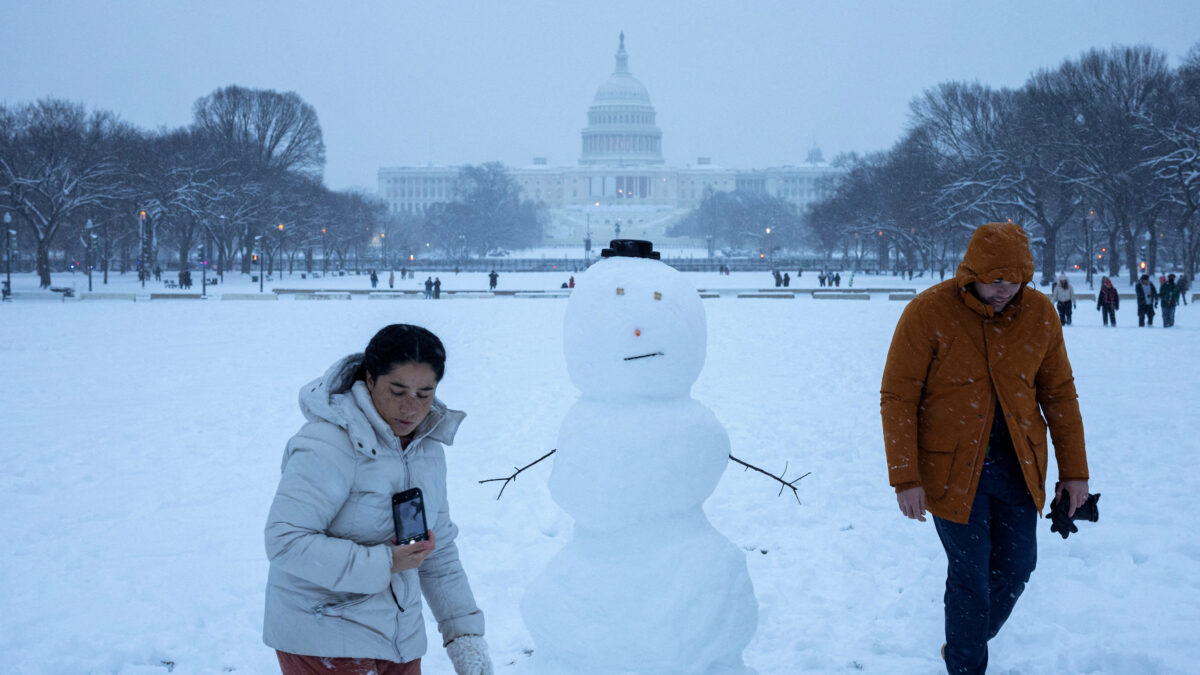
left=265, top=430, right=391, bottom=593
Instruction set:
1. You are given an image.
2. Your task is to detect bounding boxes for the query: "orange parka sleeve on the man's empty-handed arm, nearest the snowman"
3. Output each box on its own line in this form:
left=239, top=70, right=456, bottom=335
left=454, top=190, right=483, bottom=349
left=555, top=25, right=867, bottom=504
left=880, top=300, right=932, bottom=492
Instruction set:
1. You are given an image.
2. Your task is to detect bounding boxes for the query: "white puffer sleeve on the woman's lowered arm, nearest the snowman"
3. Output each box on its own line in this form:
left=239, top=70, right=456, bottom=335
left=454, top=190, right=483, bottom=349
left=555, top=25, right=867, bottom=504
left=418, top=449, right=484, bottom=646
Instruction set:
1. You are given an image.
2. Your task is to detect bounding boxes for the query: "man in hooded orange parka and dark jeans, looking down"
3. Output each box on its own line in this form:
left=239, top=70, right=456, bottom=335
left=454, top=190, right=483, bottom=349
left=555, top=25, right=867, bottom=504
left=880, top=222, right=1088, bottom=673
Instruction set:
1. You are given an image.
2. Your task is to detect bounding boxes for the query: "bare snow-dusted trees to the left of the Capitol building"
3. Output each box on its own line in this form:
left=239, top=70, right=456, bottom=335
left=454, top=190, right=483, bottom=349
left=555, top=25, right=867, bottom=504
left=0, top=86, right=544, bottom=287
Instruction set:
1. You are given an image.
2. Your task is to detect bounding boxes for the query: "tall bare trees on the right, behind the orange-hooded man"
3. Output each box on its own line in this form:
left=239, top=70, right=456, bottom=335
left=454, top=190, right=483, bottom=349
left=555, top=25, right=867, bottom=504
left=806, top=44, right=1200, bottom=282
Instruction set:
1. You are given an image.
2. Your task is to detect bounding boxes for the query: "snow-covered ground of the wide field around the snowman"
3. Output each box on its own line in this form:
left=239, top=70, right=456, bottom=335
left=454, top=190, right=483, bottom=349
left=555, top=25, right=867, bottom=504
left=0, top=271, right=1200, bottom=675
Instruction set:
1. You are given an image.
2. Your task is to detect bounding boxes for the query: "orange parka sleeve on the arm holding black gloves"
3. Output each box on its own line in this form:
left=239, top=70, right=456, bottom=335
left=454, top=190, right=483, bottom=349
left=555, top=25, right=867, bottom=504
left=1034, top=321, right=1088, bottom=480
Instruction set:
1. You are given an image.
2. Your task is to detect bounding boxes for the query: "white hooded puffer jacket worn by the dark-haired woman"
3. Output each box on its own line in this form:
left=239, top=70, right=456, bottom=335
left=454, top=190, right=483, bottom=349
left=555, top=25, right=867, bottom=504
left=263, top=354, right=484, bottom=663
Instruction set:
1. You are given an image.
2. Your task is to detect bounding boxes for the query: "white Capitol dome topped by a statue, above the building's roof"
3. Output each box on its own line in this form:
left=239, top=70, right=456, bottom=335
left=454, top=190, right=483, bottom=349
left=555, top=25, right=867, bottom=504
left=580, top=32, right=664, bottom=166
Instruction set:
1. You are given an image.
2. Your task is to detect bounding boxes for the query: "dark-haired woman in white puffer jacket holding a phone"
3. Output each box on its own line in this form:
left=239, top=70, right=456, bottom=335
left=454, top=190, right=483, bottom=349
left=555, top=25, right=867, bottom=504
left=263, top=324, right=492, bottom=675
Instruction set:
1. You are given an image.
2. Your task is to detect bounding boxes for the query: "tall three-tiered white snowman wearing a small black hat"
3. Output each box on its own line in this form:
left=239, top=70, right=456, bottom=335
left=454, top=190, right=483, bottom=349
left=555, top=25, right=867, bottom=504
left=521, top=239, right=758, bottom=674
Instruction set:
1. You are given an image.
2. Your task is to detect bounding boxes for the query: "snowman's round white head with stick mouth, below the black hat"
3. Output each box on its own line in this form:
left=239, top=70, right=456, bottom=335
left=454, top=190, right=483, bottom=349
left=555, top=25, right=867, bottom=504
left=563, top=257, right=707, bottom=398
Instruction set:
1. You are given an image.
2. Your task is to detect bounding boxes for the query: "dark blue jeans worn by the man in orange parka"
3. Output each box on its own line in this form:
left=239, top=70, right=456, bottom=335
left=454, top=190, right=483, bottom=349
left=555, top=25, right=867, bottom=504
left=934, top=450, right=1038, bottom=674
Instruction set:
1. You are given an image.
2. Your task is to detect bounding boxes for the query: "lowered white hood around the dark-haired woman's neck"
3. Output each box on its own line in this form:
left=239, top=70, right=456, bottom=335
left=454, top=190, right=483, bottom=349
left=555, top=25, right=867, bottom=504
left=300, top=353, right=467, bottom=447
